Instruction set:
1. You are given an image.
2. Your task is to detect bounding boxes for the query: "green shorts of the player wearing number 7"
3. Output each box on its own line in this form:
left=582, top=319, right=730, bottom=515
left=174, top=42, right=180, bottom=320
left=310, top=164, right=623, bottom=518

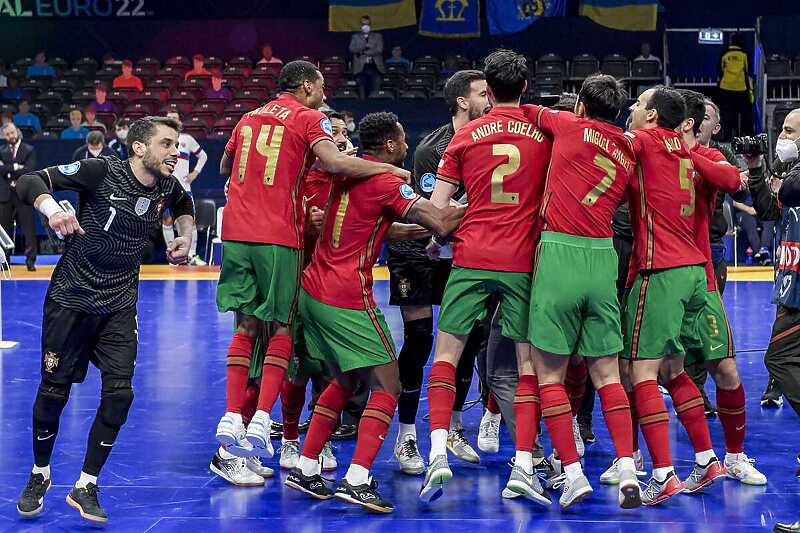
left=528, top=231, right=622, bottom=357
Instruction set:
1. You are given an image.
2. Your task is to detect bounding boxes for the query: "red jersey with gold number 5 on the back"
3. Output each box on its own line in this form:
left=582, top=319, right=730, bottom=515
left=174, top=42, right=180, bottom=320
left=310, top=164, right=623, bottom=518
left=626, top=127, right=706, bottom=275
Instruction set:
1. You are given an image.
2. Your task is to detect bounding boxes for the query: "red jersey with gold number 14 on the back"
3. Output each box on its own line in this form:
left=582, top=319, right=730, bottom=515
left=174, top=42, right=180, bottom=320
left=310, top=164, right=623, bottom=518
left=222, top=94, right=333, bottom=249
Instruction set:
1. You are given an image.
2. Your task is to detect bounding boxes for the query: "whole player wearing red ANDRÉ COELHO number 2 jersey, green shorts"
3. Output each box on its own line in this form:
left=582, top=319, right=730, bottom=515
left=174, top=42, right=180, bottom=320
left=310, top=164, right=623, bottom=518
left=420, top=50, right=550, bottom=505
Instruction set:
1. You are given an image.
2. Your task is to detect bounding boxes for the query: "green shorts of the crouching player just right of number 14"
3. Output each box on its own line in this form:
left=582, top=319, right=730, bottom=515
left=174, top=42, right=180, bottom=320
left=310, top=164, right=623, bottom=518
left=299, top=288, right=397, bottom=373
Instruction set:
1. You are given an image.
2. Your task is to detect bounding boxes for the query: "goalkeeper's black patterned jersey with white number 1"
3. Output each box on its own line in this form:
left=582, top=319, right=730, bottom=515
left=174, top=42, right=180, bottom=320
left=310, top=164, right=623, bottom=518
left=19, top=156, right=194, bottom=314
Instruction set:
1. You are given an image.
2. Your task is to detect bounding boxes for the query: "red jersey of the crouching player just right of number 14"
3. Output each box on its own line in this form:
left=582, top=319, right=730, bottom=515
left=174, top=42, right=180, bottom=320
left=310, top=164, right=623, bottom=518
left=302, top=156, right=420, bottom=309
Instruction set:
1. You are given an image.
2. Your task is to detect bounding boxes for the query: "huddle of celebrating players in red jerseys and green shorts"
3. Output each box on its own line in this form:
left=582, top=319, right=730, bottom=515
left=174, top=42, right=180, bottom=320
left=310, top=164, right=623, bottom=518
left=212, top=50, right=766, bottom=512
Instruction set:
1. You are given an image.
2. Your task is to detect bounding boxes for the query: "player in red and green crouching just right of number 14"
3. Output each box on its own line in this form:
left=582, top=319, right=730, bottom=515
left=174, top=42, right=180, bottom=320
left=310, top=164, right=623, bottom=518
left=286, top=113, right=464, bottom=513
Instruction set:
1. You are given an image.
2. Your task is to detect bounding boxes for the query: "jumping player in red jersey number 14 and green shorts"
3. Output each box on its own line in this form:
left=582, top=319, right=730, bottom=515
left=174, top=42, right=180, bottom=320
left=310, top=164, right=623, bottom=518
left=216, top=61, right=409, bottom=457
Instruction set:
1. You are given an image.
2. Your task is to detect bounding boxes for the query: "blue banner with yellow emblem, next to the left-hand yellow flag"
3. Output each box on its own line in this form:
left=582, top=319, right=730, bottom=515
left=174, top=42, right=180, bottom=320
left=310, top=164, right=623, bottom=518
left=419, top=0, right=481, bottom=39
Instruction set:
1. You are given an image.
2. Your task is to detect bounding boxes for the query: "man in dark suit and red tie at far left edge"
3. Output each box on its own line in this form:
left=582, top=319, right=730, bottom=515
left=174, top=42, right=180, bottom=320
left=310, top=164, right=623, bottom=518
left=0, top=123, right=38, bottom=271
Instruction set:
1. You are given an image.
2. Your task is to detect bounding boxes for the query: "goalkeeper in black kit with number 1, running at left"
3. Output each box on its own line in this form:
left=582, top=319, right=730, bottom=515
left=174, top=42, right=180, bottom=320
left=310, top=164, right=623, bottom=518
left=17, top=117, right=194, bottom=522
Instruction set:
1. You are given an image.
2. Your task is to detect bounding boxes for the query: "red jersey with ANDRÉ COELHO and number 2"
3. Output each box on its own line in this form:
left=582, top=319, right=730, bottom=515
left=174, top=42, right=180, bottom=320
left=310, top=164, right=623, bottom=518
left=437, top=107, right=551, bottom=272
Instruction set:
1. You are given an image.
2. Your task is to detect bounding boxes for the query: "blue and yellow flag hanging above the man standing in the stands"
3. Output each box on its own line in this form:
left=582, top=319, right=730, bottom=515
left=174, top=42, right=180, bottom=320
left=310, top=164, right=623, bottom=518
left=328, top=0, right=417, bottom=32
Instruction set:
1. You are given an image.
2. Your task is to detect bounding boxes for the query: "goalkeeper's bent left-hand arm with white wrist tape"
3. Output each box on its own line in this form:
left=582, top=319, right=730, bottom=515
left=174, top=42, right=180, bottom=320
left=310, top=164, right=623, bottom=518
left=17, top=158, right=108, bottom=236
